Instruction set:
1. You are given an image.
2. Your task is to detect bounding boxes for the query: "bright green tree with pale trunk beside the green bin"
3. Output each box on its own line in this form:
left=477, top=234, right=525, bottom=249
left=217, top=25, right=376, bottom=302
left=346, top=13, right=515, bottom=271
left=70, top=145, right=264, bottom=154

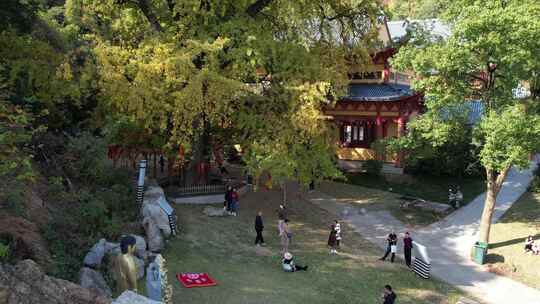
left=393, top=0, right=540, bottom=243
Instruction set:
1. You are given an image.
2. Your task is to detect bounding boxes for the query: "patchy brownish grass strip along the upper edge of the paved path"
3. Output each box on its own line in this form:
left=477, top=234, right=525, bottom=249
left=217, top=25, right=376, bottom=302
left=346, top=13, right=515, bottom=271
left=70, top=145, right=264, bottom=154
left=318, top=181, right=446, bottom=227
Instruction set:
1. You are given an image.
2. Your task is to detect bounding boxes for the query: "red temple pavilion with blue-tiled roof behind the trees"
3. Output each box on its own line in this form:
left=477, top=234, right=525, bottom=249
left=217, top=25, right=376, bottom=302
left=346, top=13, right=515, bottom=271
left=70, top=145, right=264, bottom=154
left=324, top=22, right=423, bottom=169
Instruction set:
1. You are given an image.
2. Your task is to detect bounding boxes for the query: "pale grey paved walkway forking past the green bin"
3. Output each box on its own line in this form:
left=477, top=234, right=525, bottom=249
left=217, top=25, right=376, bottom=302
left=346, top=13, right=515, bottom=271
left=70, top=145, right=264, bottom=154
left=308, top=157, right=540, bottom=304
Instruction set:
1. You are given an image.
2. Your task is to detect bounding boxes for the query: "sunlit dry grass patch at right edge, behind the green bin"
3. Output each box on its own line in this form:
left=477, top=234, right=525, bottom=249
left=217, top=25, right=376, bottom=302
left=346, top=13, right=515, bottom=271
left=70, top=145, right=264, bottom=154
left=487, top=192, right=540, bottom=289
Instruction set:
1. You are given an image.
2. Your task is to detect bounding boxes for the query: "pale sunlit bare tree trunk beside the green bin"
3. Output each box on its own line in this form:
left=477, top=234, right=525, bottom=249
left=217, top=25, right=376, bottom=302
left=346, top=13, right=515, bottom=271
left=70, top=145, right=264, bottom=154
left=480, top=167, right=510, bottom=244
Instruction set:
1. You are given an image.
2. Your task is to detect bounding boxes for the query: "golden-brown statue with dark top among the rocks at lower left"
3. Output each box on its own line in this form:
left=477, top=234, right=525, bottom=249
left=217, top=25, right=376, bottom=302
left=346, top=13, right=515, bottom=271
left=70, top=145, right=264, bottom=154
left=114, top=236, right=137, bottom=293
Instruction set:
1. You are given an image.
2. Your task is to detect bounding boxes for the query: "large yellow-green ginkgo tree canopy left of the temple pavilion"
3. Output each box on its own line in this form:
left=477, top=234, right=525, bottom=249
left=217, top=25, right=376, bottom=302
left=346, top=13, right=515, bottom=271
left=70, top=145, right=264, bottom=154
left=66, top=0, right=383, bottom=188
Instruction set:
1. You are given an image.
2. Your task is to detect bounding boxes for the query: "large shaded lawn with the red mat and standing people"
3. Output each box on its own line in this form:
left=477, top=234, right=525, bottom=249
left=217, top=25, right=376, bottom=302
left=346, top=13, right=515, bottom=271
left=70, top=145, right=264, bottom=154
left=164, top=186, right=462, bottom=304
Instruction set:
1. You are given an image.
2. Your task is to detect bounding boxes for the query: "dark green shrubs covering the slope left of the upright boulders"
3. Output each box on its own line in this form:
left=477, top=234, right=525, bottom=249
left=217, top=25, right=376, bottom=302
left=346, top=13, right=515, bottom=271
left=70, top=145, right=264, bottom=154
left=43, top=133, right=138, bottom=280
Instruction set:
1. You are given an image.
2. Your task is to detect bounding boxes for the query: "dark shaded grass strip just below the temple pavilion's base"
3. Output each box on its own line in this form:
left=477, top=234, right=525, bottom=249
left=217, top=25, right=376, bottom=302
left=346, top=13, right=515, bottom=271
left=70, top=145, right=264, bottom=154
left=346, top=173, right=486, bottom=204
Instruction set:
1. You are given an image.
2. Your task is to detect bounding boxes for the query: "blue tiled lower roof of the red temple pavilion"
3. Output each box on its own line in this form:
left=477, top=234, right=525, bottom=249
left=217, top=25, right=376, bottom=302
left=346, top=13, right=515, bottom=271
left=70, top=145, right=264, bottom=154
left=346, top=83, right=412, bottom=101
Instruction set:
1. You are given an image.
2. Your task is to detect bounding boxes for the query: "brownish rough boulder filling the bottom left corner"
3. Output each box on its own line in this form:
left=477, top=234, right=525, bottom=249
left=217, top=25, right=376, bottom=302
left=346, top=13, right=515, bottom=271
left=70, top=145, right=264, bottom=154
left=0, top=260, right=112, bottom=304
